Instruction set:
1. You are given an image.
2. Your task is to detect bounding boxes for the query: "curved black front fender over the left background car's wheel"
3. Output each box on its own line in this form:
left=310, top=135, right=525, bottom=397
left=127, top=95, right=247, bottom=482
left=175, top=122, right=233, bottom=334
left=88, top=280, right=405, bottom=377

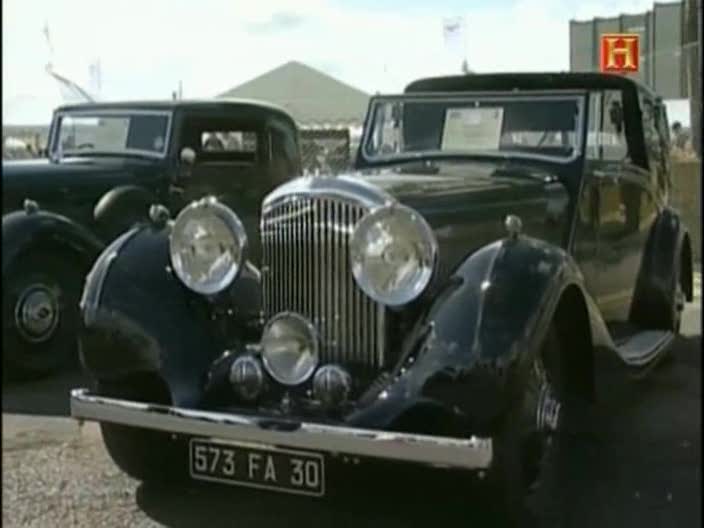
left=2, top=211, right=104, bottom=275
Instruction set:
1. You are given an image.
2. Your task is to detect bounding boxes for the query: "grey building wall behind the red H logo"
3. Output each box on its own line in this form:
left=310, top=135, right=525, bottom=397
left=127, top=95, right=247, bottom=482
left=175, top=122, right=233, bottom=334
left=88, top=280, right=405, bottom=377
left=570, top=2, right=687, bottom=99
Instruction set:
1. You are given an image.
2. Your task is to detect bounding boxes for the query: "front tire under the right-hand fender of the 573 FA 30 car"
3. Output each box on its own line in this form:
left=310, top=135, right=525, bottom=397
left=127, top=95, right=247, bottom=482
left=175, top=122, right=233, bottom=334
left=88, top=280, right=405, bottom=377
left=490, top=327, right=566, bottom=527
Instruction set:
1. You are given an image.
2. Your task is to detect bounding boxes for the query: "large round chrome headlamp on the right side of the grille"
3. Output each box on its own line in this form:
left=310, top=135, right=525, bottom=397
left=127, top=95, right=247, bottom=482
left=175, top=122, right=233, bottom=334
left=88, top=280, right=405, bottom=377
left=350, top=205, right=438, bottom=306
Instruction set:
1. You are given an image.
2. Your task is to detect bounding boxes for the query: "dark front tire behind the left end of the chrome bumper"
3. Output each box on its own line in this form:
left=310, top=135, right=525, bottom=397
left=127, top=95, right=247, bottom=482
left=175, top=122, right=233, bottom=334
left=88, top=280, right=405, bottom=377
left=98, top=374, right=188, bottom=483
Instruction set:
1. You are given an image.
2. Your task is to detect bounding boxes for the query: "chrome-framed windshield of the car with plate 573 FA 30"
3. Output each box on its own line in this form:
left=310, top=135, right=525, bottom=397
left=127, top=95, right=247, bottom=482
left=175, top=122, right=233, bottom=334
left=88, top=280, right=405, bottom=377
left=363, top=94, right=583, bottom=161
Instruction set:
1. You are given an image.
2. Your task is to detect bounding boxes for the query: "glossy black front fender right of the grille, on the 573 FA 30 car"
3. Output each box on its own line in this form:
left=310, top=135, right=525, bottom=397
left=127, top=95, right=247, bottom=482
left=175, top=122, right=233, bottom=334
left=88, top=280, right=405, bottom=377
left=350, top=237, right=588, bottom=434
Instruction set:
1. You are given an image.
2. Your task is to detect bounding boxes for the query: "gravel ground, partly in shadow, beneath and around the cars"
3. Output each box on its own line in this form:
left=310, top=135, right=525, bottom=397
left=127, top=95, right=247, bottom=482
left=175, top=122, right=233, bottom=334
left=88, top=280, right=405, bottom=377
left=2, top=292, right=701, bottom=528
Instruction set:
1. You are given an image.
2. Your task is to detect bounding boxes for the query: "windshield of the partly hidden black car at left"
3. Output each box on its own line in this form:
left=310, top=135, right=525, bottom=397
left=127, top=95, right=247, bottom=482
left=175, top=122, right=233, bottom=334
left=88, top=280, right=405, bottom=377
left=52, top=111, right=171, bottom=157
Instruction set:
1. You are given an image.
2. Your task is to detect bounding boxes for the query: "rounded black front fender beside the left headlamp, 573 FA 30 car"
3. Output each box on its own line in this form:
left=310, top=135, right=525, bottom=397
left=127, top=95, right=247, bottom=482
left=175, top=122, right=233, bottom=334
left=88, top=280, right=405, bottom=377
left=79, top=225, right=259, bottom=407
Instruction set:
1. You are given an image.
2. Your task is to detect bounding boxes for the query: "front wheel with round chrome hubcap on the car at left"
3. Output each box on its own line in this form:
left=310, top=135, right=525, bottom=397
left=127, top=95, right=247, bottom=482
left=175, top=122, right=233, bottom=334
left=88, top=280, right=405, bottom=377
left=2, top=250, right=87, bottom=379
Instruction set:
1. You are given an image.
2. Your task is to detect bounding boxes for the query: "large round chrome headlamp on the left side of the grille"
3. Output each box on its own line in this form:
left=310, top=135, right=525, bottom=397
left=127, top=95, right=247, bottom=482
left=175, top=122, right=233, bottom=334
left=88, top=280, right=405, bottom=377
left=169, top=197, right=247, bottom=295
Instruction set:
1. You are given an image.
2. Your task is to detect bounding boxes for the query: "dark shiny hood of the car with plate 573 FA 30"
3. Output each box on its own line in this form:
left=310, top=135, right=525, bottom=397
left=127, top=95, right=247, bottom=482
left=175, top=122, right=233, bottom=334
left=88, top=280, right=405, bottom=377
left=354, top=162, right=569, bottom=276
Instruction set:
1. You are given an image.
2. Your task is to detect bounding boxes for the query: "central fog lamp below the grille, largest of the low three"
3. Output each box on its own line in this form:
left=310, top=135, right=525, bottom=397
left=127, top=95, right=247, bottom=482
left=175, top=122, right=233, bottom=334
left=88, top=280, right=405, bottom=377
left=261, top=312, right=318, bottom=386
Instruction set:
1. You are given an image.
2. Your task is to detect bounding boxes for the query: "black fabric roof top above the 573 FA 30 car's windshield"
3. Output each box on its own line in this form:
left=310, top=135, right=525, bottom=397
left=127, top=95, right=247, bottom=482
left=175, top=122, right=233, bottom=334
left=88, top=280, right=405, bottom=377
left=406, top=72, right=656, bottom=97
